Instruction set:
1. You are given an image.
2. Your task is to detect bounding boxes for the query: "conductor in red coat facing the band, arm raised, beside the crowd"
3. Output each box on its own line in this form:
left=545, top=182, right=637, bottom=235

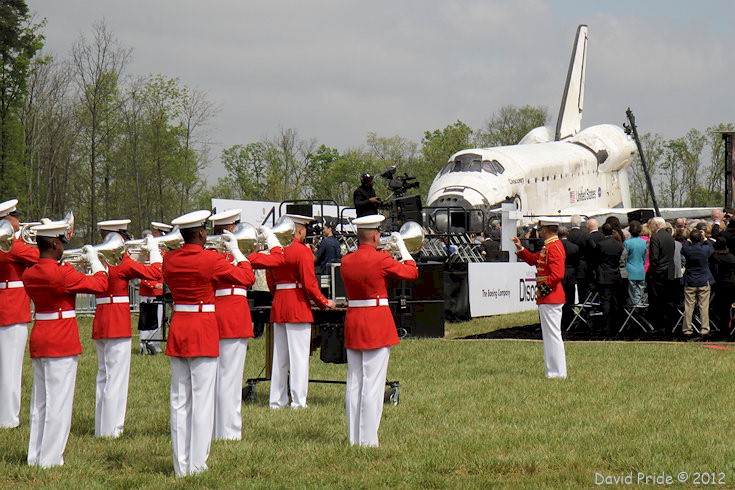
left=512, top=220, right=567, bottom=378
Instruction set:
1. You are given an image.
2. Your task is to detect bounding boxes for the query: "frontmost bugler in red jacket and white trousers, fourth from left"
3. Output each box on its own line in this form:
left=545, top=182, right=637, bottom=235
left=163, top=211, right=254, bottom=477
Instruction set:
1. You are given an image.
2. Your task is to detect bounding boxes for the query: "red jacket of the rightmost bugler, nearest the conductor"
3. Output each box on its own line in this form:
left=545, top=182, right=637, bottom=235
left=341, top=245, right=419, bottom=350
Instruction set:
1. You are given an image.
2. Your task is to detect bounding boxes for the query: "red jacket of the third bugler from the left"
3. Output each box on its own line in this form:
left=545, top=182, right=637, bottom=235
left=92, top=254, right=162, bottom=339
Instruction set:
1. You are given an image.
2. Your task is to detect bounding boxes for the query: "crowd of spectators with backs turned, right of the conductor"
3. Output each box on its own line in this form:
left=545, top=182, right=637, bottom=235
left=559, top=210, right=735, bottom=340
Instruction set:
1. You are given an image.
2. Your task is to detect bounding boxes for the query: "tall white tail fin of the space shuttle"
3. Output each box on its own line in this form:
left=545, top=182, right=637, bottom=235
left=555, top=24, right=588, bottom=141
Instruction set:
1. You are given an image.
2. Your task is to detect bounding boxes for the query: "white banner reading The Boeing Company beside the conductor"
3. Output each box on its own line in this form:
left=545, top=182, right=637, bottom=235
left=468, top=262, right=536, bottom=318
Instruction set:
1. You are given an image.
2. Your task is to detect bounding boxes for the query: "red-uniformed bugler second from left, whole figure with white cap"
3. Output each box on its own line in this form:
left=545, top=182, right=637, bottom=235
left=23, top=221, right=107, bottom=467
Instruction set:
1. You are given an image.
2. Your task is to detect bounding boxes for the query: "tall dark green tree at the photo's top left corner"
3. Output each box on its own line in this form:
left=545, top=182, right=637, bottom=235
left=0, top=0, right=44, bottom=200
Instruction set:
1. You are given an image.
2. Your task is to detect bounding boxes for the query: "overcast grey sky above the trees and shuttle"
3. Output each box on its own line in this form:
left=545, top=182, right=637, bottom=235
left=27, top=0, right=735, bottom=182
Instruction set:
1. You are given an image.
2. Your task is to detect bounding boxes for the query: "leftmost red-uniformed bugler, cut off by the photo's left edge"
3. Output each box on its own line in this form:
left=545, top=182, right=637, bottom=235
left=0, top=199, right=38, bottom=428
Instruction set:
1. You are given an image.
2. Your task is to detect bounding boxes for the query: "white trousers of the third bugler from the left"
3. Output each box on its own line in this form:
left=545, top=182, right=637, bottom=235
left=94, top=337, right=132, bottom=437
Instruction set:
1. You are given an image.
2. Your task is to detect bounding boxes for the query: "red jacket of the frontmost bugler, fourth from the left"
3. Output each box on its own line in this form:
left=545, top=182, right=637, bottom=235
left=163, top=243, right=255, bottom=357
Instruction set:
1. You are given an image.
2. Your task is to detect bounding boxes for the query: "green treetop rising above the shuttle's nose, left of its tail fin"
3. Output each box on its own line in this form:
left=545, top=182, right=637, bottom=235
left=477, top=105, right=549, bottom=147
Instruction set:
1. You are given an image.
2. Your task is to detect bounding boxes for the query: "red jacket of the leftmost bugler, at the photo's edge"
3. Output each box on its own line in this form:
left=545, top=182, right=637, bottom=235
left=0, top=239, right=38, bottom=327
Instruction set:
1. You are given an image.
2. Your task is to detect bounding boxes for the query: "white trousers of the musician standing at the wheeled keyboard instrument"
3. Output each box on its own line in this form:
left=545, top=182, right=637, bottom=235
left=270, top=323, right=311, bottom=408
